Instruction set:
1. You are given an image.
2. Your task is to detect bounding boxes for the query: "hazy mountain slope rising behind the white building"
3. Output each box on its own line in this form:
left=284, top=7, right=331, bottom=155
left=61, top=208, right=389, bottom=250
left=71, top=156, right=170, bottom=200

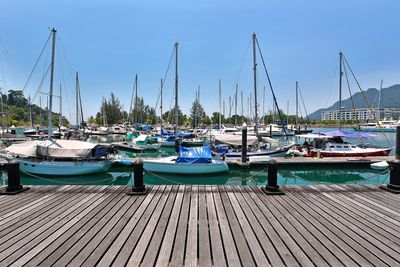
left=309, top=84, right=400, bottom=119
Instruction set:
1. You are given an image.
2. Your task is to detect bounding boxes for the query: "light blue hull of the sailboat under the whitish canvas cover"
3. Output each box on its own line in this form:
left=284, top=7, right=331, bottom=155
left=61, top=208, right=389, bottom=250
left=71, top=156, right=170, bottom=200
left=19, top=159, right=112, bottom=176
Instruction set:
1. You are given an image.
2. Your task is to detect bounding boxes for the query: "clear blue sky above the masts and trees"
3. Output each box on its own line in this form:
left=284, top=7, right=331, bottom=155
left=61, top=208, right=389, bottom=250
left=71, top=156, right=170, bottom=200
left=0, top=0, right=400, bottom=121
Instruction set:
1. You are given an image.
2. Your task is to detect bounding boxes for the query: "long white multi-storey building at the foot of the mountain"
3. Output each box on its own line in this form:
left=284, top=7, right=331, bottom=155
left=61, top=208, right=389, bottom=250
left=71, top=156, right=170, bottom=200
left=321, top=108, right=400, bottom=121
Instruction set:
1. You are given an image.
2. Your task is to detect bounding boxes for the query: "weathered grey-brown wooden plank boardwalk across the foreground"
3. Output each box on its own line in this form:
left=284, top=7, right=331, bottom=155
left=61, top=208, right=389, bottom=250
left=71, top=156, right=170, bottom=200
left=0, top=185, right=400, bottom=266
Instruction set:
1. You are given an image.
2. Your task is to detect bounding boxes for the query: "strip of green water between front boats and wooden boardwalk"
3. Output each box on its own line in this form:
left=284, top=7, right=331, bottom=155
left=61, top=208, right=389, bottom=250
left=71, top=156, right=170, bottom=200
left=7, top=164, right=389, bottom=186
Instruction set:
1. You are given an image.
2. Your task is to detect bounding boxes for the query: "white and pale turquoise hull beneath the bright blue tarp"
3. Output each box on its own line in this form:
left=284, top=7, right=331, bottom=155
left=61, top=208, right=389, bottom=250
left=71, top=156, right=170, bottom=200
left=143, top=157, right=229, bottom=175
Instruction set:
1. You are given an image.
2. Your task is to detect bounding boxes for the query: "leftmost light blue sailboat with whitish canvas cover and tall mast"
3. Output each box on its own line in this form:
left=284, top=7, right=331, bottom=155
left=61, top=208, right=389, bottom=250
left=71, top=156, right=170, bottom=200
left=4, top=28, right=112, bottom=176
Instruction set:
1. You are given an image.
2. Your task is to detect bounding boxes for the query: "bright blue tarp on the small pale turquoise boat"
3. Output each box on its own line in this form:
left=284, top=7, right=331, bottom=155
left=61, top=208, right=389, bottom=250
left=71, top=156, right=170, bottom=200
left=176, top=146, right=211, bottom=164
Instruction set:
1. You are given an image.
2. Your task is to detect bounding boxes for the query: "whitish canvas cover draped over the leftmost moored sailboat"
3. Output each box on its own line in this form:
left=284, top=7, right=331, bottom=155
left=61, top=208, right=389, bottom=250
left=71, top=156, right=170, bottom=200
left=5, top=140, right=99, bottom=158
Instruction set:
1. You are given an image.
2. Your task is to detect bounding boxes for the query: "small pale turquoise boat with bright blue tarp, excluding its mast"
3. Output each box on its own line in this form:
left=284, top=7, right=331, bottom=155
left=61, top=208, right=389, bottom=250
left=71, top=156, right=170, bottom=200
left=143, top=146, right=229, bottom=175
